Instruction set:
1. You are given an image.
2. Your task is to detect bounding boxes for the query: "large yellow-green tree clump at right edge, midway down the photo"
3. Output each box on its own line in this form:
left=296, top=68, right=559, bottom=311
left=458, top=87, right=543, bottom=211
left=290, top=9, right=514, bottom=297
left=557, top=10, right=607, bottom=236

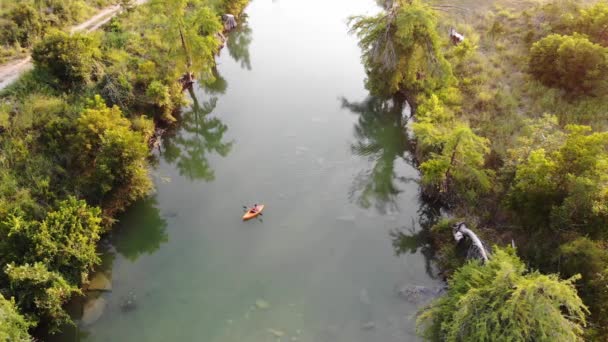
left=508, top=125, right=608, bottom=237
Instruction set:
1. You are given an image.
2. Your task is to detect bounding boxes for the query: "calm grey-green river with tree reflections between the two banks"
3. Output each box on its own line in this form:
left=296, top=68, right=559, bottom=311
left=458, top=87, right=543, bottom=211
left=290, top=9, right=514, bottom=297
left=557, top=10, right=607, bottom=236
left=65, top=0, right=441, bottom=342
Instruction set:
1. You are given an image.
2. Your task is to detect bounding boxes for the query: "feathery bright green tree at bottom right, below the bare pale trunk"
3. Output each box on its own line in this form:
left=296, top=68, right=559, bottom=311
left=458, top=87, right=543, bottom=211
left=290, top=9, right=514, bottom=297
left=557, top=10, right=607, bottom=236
left=417, top=248, right=588, bottom=341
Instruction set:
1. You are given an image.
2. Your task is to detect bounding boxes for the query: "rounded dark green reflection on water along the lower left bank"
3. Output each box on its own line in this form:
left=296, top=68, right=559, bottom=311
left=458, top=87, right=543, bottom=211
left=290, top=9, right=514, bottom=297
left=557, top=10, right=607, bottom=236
left=111, top=196, right=169, bottom=261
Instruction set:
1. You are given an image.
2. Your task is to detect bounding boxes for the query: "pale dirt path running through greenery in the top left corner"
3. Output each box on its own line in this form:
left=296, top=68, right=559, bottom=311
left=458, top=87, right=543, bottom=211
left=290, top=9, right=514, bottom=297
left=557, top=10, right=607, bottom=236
left=0, top=0, right=146, bottom=90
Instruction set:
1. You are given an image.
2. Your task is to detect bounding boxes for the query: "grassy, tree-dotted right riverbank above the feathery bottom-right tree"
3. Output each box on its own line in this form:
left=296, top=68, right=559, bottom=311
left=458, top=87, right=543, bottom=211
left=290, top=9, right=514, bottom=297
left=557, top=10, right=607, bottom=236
left=354, top=1, right=608, bottom=340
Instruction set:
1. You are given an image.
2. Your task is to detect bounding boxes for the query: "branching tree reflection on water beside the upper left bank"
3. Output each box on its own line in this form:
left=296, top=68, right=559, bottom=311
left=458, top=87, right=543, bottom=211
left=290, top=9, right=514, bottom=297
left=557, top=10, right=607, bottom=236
left=161, top=90, right=233, bottom=181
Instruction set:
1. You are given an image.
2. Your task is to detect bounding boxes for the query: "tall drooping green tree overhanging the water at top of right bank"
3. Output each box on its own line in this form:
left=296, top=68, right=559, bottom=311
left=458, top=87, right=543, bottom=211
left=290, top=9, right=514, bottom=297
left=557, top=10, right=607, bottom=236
left=350, top=0, right=452, bottom=100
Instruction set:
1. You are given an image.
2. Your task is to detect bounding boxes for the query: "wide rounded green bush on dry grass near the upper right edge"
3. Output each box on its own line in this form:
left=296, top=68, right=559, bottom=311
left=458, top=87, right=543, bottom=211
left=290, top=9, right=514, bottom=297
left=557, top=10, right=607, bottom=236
left=529, top=34, right=608, bottom=94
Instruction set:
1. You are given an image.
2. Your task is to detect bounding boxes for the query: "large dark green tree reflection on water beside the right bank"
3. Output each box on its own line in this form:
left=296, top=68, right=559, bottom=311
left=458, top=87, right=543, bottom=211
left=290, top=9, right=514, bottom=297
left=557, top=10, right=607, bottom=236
left=342, top=96, right=413, bottom=213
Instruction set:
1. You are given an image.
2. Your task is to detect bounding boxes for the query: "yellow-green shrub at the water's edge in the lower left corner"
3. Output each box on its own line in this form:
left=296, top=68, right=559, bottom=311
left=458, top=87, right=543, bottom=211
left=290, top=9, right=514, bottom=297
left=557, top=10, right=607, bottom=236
left=5, top=262, right=80, bottom=331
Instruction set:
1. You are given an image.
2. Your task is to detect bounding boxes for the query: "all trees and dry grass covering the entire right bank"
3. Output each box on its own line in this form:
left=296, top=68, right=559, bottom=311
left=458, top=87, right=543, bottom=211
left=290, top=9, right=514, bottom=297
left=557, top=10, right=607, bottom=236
left=351, top=0, right=608, bottom=341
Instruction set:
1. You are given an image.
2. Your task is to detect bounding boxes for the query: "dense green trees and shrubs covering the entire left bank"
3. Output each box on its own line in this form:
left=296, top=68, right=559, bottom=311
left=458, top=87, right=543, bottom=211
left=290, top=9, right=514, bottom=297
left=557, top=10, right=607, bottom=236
left=0, top=0, right=247, bottom=340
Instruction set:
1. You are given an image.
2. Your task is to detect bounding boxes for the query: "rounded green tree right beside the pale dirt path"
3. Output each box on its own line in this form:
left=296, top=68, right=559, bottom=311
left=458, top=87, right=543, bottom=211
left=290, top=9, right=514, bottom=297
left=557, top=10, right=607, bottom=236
left=32, top=31, right=100, bottom=88
